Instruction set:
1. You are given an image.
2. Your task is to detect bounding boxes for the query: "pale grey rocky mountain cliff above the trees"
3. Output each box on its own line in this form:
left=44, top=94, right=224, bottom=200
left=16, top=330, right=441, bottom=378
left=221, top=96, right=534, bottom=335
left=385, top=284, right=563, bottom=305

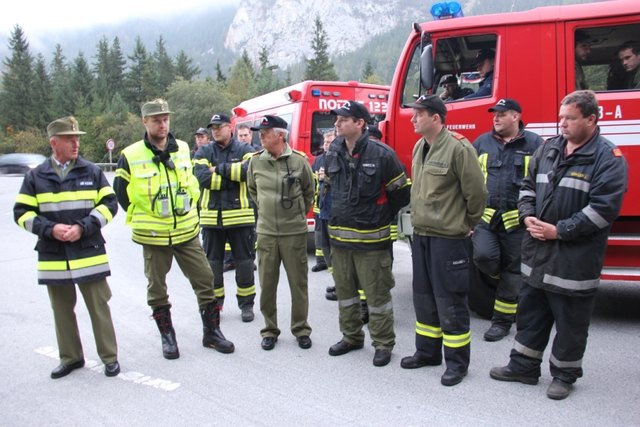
left=224, top=0, right=428, bottom=68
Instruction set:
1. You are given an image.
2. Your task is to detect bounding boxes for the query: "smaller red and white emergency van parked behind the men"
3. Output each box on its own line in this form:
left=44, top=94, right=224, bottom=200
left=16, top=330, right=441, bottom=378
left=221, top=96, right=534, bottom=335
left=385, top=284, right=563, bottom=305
left=231, top=81, right=389, bottom=232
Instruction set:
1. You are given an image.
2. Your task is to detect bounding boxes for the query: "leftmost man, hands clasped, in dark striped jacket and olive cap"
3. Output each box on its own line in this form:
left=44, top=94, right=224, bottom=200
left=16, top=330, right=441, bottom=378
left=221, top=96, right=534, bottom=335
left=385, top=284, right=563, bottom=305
left=13, top=117, right=120, bottom=379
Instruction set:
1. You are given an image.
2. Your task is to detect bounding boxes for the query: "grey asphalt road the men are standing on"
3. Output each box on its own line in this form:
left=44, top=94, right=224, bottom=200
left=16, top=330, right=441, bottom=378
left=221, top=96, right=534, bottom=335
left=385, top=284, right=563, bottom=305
left=0, top=176, right=640, bottom=426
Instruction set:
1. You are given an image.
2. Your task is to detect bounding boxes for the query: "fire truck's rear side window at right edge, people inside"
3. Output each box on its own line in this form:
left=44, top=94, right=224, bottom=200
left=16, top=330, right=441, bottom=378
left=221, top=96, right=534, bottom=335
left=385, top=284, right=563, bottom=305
left=567, top=24, right=640, bottom=92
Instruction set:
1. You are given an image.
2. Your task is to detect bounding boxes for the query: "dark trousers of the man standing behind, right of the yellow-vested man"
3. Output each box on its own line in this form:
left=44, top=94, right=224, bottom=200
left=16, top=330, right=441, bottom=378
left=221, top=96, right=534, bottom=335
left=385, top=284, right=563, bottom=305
left=202, top=227, right=256, bottom=308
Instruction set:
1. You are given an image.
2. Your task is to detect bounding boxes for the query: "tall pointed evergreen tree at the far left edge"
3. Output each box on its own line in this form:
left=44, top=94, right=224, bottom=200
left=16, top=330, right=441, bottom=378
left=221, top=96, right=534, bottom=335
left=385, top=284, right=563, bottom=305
left=0, top=25, right=38, bottom=133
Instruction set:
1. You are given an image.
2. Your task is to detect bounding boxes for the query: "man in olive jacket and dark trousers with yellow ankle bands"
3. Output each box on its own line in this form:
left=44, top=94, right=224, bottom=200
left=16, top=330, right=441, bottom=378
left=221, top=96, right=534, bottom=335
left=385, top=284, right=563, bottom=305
left=400, top=95, right=487, bottom=386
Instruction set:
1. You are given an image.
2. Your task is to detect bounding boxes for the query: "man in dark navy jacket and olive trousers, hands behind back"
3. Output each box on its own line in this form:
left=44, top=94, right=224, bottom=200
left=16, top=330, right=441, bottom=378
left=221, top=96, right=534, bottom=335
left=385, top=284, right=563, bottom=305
left=325, top=101, right=411, bottom=366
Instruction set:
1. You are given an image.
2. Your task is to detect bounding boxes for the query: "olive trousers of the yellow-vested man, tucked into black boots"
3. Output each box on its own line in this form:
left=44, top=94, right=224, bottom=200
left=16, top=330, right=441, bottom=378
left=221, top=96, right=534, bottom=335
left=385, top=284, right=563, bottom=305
left=142, top=236, right=216, bottom=310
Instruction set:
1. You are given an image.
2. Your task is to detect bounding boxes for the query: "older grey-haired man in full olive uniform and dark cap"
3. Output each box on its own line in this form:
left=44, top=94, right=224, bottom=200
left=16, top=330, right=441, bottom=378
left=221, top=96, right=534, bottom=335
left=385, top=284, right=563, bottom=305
left=247, top=115, right=315, bottom=350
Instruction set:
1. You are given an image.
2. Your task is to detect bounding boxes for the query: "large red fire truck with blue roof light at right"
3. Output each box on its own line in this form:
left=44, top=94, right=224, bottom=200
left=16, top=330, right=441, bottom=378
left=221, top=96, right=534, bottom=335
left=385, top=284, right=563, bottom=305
left=380, top=0, right=640, bottom=314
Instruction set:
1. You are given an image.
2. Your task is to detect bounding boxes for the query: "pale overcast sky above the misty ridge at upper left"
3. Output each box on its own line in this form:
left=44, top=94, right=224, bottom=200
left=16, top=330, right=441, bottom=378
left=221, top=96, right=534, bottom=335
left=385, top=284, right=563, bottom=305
left=0, top=0, right=239, bottom=37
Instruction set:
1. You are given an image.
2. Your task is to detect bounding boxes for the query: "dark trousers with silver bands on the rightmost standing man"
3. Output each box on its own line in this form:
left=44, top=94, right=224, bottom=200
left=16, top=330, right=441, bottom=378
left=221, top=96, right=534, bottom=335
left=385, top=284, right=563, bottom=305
left=509, top=283, right=596, bottom=383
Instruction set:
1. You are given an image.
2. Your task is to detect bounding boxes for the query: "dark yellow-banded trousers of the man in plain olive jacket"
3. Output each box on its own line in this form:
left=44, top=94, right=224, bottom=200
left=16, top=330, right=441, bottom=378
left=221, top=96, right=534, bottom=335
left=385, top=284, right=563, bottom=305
left=411, top=234, right=471, bottom=372
